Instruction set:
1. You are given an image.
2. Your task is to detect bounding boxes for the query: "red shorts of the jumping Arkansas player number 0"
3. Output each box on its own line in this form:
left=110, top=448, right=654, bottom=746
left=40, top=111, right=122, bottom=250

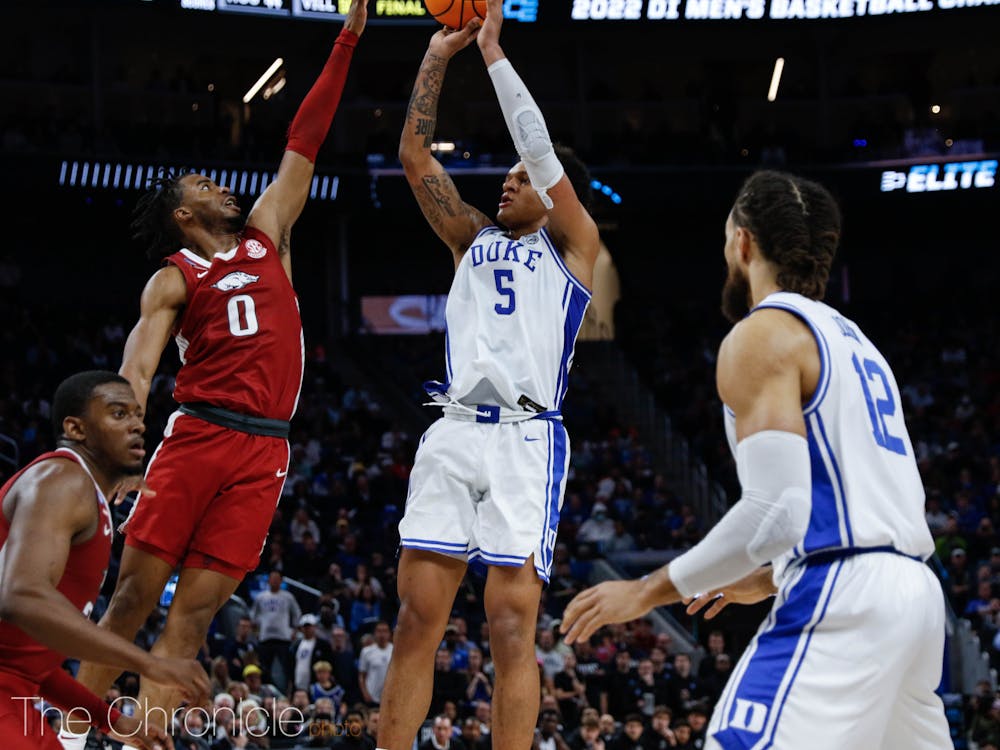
left=122, top=412, right=289, bottom=580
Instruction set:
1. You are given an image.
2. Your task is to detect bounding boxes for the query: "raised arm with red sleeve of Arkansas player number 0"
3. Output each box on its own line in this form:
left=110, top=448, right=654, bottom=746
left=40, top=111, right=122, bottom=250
left=247, top=0, right=368, bottom=278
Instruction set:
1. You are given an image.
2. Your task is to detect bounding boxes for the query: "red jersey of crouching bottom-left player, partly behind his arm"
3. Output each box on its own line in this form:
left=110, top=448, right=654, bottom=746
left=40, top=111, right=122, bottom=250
left=0, top=448, right=112, bottom=682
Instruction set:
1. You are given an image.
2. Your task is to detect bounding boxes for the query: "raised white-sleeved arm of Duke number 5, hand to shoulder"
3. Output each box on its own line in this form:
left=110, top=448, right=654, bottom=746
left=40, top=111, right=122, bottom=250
left=476, top=0, right=601, bottom=287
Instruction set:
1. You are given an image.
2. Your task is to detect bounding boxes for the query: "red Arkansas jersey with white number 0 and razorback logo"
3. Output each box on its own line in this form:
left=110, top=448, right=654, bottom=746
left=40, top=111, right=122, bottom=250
left=166, top=227, right=305, bottom=420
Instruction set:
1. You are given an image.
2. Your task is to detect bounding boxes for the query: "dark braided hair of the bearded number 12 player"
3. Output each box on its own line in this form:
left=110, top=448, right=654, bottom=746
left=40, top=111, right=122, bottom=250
left=733, top=170, right=840, bottom=299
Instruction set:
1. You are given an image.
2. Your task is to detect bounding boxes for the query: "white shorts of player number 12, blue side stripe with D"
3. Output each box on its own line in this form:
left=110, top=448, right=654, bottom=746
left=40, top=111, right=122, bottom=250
left=705, top=553, right=952, bottom=750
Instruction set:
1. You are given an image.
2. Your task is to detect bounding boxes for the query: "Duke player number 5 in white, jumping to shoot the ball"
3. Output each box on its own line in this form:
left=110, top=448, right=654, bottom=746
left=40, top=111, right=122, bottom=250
left=378, top=0, right=600, bottom=750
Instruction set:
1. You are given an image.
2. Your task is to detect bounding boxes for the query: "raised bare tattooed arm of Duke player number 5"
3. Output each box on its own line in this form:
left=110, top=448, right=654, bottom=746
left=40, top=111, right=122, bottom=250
left=399, top=26, right=492, bottom=266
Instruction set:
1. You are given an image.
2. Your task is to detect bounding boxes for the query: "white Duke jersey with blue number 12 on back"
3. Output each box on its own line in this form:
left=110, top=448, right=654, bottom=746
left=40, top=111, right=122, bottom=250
left=725, top=292, right=934, bottom=575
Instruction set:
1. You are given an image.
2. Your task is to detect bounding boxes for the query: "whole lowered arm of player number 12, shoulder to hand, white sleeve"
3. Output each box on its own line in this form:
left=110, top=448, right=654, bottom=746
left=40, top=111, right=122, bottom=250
left=561, top=310, right=818, bottom=643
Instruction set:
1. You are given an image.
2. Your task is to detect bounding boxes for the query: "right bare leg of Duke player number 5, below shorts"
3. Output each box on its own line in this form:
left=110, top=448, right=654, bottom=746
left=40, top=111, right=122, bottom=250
left=484, top=556, right=542, bottom=748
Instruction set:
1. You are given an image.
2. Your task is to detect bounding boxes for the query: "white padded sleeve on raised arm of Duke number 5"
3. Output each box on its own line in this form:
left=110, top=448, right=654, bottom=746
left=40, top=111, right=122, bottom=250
left=487, top=57, right=564, bottom=208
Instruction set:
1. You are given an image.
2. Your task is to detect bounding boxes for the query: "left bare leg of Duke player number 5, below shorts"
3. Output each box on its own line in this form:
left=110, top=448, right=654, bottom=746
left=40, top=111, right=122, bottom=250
left=378, top=549, right=466, bottom=750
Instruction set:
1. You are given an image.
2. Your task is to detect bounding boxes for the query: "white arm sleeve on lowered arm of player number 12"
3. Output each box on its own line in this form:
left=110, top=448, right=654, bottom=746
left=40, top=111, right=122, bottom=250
left=667, top=430, right=812, bottom=597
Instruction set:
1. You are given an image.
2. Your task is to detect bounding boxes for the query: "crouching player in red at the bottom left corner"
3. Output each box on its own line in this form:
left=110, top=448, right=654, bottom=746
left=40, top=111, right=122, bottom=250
left=0, top=371, right=208, bottom=750
